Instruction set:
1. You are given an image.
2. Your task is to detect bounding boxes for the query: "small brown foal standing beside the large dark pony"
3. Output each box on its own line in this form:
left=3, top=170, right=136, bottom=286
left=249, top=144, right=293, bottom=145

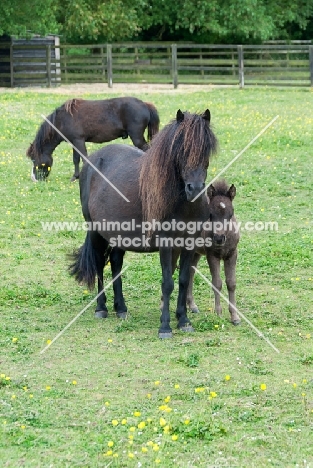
left=187, top=180, right=240, bottom=325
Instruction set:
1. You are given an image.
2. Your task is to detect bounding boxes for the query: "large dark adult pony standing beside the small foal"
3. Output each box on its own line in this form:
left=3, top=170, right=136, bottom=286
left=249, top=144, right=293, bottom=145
left=70, top=110, right=217, bottom=338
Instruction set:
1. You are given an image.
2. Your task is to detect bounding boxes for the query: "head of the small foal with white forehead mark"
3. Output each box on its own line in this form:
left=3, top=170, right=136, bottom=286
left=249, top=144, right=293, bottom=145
left=207, top=180, right=236, bottom=247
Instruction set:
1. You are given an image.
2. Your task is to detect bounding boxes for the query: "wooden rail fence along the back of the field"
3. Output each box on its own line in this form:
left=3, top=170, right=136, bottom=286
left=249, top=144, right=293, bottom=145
left=0, top=43, right=313, bottom=88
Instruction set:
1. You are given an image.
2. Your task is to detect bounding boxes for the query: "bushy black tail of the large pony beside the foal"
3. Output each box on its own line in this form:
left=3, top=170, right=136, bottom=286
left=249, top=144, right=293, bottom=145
left=69, top=231, right=97, bottom=290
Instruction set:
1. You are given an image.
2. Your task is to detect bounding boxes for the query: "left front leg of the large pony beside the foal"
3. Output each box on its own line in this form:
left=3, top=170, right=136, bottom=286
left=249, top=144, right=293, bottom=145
left=159, top=247, right=174, bottom=338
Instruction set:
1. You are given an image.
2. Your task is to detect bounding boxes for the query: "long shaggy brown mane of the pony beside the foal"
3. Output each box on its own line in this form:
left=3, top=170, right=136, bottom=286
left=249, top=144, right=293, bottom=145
left=139, top=112, right=217, bottom=221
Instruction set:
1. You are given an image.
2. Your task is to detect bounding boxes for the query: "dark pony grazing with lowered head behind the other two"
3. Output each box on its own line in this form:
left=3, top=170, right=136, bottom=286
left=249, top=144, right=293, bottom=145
left=26, top=97, right=160, bottom=181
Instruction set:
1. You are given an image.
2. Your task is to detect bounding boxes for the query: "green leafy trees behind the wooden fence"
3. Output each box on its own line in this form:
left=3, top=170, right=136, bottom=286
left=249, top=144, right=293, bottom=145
left=0, top=0, right=313, bottom=43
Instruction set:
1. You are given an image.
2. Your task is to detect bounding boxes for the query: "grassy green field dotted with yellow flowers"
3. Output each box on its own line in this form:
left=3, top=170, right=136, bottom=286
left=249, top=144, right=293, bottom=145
left=0, top=88, right=313, bottom=468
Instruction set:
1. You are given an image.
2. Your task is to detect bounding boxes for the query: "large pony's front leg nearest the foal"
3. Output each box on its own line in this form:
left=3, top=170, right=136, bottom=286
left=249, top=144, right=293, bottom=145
left=176, top=249, right=194, bottom=332
